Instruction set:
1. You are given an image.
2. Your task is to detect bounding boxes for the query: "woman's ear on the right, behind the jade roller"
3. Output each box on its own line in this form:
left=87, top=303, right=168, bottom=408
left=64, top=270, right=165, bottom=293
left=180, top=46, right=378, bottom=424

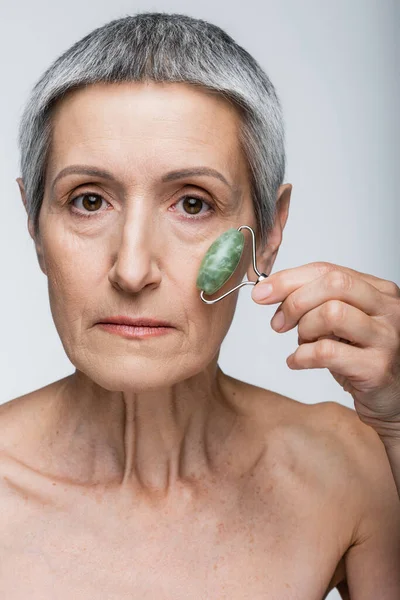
left=247, top=183, right=292, bottom=281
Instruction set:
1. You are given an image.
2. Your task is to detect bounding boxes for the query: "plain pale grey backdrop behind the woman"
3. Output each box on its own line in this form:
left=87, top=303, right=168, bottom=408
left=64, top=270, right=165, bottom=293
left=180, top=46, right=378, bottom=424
left=0, top=0, right=400, bottom=600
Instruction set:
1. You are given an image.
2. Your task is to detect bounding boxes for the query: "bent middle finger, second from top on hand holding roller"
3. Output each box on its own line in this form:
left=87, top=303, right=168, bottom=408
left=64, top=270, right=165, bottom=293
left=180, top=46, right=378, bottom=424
left=271, top=270, right=386, bottom=333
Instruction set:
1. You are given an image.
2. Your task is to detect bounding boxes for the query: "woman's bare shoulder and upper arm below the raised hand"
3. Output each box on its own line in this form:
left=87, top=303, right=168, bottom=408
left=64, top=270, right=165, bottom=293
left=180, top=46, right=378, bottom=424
left=231, top=384, right=400, bottom=600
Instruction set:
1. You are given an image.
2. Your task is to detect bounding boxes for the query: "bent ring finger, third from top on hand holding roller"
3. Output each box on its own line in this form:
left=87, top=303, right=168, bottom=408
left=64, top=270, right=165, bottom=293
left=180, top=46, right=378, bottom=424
left=298, top=300, right=388, bottom=348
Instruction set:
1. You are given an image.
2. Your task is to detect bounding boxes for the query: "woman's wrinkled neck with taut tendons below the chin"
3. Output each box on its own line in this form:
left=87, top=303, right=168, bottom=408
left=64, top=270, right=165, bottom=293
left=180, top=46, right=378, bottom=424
left=42, top=362, right=238, bottom=495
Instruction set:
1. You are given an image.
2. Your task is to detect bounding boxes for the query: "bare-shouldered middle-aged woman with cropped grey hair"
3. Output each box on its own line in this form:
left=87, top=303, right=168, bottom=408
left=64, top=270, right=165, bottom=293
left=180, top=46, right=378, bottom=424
left=0, top=13, right=400, bottom=600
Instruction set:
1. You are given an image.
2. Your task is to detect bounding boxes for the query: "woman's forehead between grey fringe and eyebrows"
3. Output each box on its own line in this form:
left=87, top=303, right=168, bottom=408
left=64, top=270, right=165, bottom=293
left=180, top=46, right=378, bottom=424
left=48, top=82, right=243, bottom=175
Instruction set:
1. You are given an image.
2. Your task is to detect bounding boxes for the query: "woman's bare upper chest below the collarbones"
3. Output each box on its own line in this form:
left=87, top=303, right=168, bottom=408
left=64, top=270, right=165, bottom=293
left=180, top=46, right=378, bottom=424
left=0, top=474, right=345, bottom=600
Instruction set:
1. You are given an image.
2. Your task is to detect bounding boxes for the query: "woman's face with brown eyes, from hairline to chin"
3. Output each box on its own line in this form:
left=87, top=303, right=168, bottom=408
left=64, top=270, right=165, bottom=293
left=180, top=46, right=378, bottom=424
left=21, top=82, right=256, bottom=391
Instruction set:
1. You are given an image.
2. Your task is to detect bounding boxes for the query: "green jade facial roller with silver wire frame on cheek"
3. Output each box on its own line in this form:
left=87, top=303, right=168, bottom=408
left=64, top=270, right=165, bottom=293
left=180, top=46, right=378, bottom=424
left=196, top=225, right=268, bottom=304
